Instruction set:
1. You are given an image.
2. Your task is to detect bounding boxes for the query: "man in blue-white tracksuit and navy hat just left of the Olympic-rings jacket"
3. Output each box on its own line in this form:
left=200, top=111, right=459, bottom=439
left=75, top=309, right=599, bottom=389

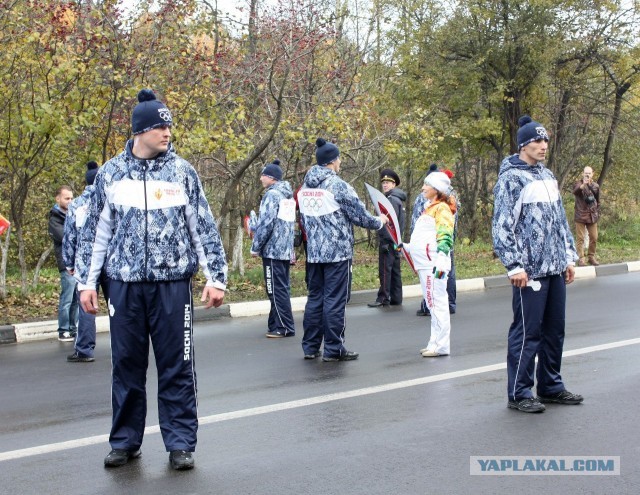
left=251, top=160, right=296, bottom=338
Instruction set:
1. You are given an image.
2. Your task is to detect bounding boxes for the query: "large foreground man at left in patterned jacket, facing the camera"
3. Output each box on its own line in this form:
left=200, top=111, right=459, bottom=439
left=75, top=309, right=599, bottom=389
left=76, top=90, right=227, bottom=469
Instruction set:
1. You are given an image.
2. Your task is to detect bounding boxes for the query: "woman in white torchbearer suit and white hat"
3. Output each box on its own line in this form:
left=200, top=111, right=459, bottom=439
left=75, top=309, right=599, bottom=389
left=404, top=172, right=456, bottom=357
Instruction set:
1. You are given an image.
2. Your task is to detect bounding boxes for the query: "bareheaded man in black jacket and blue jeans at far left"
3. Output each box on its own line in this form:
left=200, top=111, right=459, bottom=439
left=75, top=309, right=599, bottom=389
left=48, top=186, right=78, bottom=342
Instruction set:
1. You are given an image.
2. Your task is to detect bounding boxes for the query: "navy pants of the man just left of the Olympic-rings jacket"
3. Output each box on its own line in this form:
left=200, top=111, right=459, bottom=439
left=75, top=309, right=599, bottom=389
left=262, top=258, right=296, bottom=336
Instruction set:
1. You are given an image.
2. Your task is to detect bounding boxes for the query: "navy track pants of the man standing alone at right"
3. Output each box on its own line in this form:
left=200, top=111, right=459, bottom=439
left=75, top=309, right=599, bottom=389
left=507, top=275, right=566, bottom=400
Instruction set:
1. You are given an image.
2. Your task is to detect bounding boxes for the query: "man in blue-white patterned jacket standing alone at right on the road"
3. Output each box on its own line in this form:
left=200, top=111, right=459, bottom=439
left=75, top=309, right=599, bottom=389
left=493, top=116, right=583, bottom=413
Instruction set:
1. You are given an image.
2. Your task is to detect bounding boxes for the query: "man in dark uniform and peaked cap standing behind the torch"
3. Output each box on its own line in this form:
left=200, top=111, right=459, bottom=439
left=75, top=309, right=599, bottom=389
left=368, top=172, right=407, bottom=308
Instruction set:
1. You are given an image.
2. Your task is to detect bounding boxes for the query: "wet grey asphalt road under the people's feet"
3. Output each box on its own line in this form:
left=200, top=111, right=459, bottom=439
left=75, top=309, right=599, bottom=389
left=0, top=272, right=640, bottom=495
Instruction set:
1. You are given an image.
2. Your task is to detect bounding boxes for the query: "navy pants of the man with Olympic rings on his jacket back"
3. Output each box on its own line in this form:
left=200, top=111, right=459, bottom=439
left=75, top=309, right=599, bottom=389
left=302, top=260, right=351, bottom=357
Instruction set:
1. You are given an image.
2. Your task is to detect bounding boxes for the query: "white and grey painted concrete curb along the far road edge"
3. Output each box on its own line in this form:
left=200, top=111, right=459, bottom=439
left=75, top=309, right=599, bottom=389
left=6, top=261, right=640, bottom=344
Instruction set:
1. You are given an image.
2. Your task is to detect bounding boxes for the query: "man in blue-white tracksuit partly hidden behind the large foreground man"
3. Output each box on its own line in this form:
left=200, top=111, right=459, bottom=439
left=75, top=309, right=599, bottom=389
left=62, top=161, right=109, bottom=363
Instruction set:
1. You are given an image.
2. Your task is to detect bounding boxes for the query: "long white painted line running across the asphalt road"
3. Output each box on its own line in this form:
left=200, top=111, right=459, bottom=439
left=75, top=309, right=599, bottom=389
left=0, top=338, right=640, bottom=462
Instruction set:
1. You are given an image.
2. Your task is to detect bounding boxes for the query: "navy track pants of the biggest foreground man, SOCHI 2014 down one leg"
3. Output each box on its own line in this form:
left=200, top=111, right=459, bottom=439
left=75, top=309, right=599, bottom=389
left=109, top=280, right=198, bottom=452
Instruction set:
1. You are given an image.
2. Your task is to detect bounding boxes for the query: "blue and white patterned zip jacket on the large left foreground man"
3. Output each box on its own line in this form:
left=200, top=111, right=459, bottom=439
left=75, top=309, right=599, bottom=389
left=75, top=141, right=227, bottom=290
